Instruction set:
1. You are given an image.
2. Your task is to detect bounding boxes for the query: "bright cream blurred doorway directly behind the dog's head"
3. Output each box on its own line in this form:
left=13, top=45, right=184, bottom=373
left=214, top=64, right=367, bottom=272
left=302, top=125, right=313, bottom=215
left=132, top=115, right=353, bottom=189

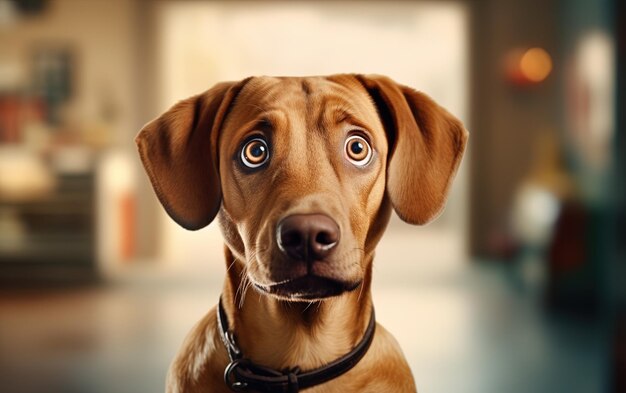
left=157, top=1, right=469, bottom=275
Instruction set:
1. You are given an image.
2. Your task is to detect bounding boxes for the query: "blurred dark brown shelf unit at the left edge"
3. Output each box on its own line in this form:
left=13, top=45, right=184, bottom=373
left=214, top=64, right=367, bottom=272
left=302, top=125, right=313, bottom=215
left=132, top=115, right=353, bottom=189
left=0, top=173, right=97, bottom=284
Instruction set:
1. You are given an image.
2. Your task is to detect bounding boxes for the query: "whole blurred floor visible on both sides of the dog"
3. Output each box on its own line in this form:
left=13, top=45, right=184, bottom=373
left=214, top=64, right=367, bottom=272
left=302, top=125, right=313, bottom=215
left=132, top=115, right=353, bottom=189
left=0, top=251, right=605, bottom=393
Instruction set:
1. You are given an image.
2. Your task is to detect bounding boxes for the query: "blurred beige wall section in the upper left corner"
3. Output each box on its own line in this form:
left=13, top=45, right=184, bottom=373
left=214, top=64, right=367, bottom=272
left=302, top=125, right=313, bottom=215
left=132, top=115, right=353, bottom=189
left=0, top=0, right=137, bottom=146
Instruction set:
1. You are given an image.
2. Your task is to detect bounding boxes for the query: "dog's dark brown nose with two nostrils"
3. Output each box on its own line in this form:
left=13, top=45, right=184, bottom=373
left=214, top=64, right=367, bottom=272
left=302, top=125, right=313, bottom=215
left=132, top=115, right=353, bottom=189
left=276, top=214, right=339, bottom=261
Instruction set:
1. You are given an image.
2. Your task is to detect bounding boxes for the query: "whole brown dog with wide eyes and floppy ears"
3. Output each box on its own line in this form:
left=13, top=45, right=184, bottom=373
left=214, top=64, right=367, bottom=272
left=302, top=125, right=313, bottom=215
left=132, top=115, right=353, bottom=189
left=137, top=75, right=467, bottom=392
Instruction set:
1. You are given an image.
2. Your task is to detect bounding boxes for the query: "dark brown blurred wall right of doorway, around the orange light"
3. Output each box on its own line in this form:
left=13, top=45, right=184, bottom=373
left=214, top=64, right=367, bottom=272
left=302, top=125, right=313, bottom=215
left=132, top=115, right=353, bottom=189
left=469, top=0, right=562, bottom=256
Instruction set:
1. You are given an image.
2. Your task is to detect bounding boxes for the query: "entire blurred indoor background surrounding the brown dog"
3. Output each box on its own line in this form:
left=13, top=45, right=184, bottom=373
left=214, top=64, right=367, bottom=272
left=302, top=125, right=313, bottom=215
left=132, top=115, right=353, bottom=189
left=0, top=0, right=626, bottom=393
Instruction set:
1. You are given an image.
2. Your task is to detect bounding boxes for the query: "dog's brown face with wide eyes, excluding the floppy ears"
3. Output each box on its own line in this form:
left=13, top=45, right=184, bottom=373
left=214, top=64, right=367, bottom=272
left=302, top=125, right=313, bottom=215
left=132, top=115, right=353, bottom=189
left=219, top=78, right=387, bottom=299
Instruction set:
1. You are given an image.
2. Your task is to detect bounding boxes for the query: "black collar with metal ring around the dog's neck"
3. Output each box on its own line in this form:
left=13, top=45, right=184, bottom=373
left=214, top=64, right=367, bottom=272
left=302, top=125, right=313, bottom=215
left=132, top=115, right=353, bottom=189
left=217, top=298, right=376, bottom=393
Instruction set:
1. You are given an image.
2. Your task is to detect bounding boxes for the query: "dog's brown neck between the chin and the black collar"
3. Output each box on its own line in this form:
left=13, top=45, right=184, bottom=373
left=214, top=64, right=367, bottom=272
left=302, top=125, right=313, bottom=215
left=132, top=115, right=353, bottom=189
left=222, top=251, right=372, bottom=370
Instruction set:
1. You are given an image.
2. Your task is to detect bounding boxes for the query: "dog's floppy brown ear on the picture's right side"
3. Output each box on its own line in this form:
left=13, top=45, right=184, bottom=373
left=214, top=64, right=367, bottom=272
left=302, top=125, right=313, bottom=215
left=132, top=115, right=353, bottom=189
left=357, top=75, right=468, bottom=224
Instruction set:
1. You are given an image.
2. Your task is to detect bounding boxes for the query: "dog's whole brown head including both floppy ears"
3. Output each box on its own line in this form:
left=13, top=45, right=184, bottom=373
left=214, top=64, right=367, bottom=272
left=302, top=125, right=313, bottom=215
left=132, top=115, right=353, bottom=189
left=137, top=75, right=467, bottom=300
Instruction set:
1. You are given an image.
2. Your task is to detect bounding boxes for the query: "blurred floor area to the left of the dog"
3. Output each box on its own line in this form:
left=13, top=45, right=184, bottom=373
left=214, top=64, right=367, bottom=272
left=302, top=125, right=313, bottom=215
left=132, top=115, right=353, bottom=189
left=0, top=264, right=220, bottom=393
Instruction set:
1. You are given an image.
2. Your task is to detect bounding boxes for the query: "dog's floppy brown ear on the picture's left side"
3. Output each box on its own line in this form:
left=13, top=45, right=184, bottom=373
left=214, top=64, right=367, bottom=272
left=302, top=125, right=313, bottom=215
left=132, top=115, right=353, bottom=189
left=135, top=79, right=247, bottom=230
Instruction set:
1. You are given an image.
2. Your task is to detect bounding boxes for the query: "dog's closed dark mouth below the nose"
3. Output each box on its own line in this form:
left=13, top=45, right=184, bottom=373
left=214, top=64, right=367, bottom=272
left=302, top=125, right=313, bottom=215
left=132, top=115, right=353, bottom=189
left=254, top=274, right=361, bottom=301
